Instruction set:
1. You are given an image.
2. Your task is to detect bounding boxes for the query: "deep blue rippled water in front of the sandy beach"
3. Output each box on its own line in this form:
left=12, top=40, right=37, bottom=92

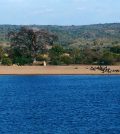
left=0, top=76, right=120, bottom=134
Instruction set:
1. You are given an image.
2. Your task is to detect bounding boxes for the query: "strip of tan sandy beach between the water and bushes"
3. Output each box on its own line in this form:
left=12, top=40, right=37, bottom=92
left=0, top=65, right=120, bottom=75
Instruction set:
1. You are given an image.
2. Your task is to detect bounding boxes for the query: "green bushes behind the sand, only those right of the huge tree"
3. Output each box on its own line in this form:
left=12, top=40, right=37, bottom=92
left=45, top=45, right=120, bottom=65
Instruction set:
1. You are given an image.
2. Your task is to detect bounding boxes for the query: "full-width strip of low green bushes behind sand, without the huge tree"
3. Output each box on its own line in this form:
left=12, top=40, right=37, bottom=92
left=0, top=45, right=120, bottom=65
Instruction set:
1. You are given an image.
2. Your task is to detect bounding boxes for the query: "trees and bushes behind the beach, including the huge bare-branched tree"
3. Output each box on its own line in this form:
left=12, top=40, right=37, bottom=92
left=0, top=27, right=120, bottom=65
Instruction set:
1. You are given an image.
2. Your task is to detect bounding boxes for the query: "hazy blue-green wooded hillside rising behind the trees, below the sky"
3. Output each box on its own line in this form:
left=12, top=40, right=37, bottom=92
left=0, top=23, right=120, bottom=47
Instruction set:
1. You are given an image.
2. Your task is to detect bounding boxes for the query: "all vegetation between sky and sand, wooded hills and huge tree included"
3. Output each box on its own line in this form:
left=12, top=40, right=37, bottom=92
left=0, top=23, right=120, bottom=65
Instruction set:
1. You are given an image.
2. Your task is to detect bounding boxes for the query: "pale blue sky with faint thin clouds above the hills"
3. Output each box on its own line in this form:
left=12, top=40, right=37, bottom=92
left=0, top=0, right=120, bottom=25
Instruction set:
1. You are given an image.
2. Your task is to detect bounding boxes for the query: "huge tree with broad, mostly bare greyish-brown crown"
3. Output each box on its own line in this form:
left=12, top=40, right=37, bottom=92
left=9, top=27, right=57, bottom=60
